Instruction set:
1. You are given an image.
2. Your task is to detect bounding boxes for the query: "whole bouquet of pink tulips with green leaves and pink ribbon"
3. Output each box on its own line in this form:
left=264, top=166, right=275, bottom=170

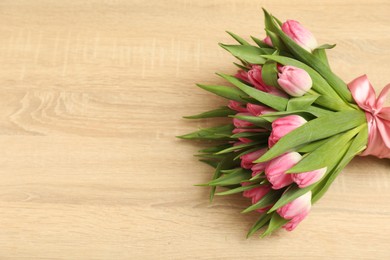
left=180, top=10, right=390, bottom=236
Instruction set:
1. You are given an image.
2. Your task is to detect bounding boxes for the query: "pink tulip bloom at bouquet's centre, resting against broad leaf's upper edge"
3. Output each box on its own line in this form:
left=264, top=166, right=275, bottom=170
left=268, top=115, right=307, bottom=148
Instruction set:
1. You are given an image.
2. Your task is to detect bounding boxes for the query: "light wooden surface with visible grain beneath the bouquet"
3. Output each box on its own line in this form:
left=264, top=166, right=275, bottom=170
left=0, top=0, right=390, bottom=259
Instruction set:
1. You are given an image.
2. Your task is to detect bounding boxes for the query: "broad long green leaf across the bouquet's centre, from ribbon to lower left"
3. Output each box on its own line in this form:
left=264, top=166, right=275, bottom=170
left=255, top=110, right=366, bottom=163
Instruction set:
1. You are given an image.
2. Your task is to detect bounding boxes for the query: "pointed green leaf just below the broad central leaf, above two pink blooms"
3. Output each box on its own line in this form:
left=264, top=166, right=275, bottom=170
left=286, top=127, right=362, bottom=173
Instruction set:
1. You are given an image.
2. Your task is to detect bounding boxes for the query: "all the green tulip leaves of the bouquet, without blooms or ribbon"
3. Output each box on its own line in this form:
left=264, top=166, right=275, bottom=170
left=178, top=9, right=368, bottom=237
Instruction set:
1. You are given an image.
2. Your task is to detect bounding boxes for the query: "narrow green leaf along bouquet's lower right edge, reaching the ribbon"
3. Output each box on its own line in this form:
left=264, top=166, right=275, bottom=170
left=312, top=124, right=368, bottom=203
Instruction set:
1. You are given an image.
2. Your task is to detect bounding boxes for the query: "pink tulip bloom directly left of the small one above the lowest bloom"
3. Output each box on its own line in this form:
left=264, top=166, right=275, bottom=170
left=265, top=152, right=302, bottom=190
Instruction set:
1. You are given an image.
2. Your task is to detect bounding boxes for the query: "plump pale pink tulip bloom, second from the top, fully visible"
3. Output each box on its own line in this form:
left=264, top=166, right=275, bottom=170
left=278, top=66, right=313, bottom=97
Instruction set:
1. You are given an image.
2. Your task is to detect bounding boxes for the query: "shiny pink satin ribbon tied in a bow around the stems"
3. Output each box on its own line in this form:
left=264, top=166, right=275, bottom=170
left=348, top=75, right=390, bottom=158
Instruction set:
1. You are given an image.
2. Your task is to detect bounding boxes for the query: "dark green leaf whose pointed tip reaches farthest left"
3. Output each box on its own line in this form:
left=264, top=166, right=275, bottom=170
left=177, top=124, right=234, bottom=140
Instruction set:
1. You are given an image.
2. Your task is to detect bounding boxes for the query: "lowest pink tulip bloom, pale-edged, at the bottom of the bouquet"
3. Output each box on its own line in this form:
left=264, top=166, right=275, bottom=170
left=277, top=191, right=311, bottom=231
